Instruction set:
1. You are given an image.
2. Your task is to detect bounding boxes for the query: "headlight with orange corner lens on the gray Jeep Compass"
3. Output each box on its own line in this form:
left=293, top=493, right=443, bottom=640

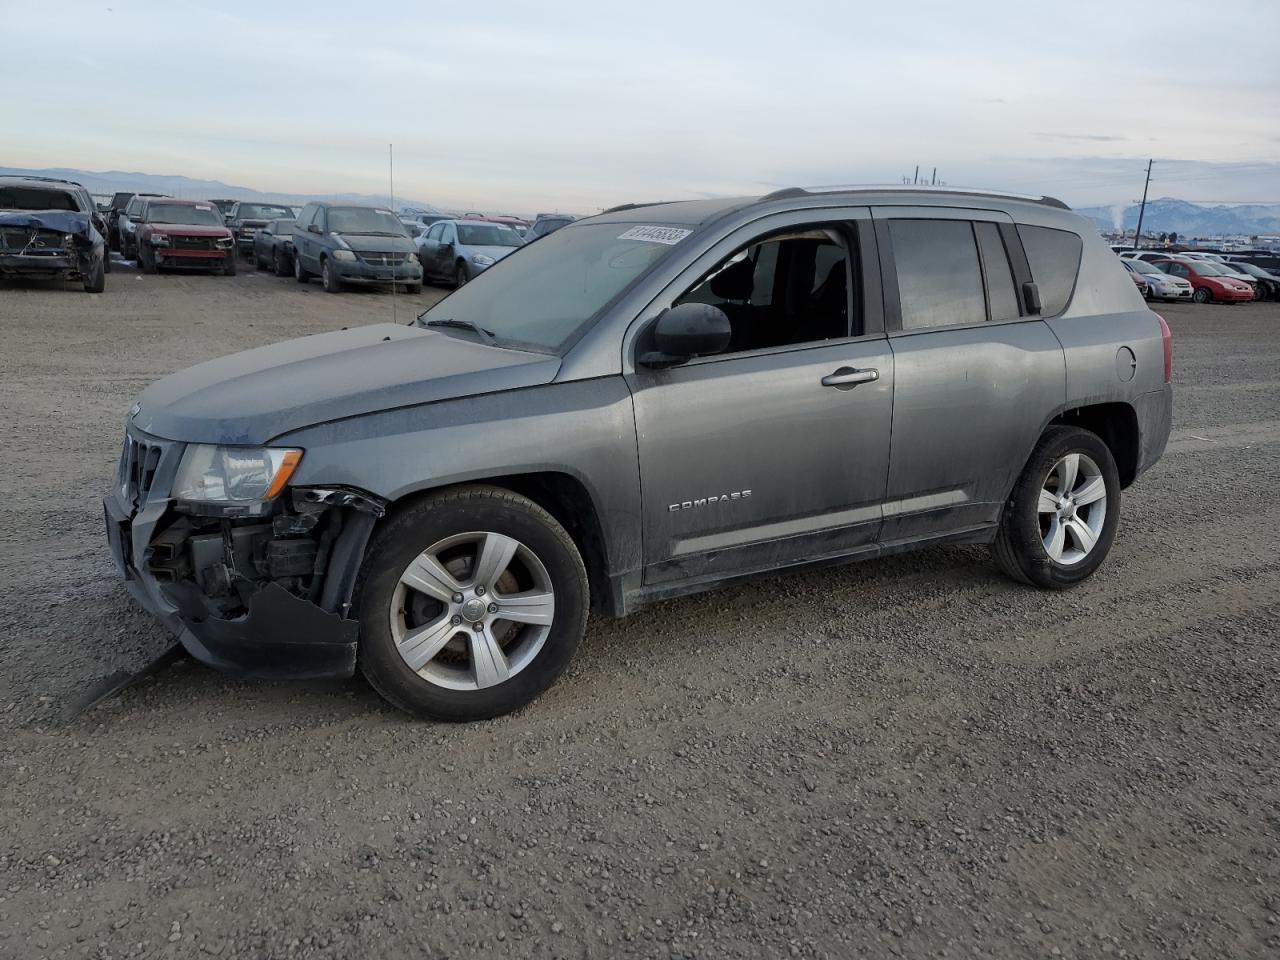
left=173, top=443, right=302, bottom=503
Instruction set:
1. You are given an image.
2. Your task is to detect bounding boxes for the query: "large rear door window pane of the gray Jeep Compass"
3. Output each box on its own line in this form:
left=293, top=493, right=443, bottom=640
left=888, top=220, right=987, bottom=330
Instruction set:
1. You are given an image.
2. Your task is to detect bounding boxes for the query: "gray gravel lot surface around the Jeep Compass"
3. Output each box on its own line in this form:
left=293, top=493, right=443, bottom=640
left=0, top=257, right=1280, bottom=960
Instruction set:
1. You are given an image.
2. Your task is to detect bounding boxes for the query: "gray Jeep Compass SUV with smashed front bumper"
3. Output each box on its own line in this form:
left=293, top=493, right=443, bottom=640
left=105, top=189, right=1171, bottom=719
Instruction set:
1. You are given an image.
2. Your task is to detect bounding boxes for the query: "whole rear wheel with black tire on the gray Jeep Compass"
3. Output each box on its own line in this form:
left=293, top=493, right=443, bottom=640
left=992, top=426, right=1120, bottom=590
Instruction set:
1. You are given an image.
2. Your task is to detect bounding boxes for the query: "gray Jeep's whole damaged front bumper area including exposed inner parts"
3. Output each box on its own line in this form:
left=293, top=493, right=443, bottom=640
left=102, top=434, right=384, bottom=680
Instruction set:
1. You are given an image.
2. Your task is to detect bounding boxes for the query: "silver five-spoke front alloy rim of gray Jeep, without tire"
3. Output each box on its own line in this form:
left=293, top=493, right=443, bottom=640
left=389, top=531, right=556, bottom=690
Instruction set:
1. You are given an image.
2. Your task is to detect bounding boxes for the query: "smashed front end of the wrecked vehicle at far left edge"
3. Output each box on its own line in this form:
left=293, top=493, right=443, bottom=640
left=0, top=210, right=106, bottom=279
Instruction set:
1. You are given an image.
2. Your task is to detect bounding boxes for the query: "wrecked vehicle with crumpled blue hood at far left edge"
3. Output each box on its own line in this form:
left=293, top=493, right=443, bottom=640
left=0, top=177, right=108, bottom=293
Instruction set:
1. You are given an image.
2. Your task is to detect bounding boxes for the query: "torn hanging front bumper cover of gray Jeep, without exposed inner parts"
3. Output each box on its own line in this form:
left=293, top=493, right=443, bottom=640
left=102, top=494, right=371, bottom=680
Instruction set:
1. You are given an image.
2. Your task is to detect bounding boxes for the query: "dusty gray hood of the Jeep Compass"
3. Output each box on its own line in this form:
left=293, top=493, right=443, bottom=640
left=133, top=324, right=559, bottom=444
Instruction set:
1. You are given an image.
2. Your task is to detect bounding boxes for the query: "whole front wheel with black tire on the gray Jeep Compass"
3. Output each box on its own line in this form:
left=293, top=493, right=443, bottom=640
left=356, top=486, right=590, bottom=721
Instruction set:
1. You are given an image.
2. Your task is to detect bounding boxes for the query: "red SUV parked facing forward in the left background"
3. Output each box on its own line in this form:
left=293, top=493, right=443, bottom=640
left=137, top=197, right=236, bottom=276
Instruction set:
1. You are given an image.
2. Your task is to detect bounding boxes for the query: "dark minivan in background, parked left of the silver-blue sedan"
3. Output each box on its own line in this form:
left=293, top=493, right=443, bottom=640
left=293, top=204, right=422, bottom=293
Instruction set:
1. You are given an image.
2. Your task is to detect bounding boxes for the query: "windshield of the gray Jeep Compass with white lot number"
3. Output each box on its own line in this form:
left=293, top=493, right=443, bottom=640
left=420, top=223, right=689, bottom=352
